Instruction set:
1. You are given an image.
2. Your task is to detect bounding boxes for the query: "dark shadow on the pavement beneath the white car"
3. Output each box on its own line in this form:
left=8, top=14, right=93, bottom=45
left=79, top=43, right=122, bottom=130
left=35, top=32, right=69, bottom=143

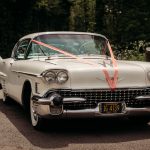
left=0, top=101, right=150, bottom=148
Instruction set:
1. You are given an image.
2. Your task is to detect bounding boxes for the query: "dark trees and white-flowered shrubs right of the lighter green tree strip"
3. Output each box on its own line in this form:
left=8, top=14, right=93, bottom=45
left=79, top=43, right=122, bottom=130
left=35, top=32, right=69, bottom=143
left=96, top=0, right=150, bottom=60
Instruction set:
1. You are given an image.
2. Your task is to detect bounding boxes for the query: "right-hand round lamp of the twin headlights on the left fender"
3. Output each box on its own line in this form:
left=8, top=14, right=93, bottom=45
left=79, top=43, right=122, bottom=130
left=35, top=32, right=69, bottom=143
left=57, top=71, right=68, bottom=84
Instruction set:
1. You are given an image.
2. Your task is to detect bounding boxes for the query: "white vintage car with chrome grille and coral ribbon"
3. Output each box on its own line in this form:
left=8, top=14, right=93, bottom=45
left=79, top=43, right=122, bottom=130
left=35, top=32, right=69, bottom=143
left=0, top=32, right=150, bottom=129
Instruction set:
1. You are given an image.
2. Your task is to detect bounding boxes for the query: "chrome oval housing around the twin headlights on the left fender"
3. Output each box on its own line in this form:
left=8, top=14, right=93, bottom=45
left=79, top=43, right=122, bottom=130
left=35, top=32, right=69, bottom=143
left=41, top=69, right=69, bottom=84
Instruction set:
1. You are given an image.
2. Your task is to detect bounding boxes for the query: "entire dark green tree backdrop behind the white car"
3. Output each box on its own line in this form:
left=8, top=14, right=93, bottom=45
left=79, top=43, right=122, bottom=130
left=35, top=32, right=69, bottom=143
left=0, top=0, right=150, bottom=60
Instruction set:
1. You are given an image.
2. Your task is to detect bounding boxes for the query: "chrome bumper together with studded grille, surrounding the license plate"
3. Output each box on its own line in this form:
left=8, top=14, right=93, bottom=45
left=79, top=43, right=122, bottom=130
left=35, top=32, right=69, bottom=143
left=32, top=88, right=150, bottom=118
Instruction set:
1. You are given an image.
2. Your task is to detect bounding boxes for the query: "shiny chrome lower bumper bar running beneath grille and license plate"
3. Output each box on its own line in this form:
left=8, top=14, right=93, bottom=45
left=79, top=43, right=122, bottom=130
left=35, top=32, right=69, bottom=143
left=31, top=99, right=150, bottom=118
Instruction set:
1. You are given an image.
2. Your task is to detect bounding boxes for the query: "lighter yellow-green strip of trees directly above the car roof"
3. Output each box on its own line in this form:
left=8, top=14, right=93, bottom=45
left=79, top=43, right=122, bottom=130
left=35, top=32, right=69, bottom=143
left=69, top=0, right=96, bottom=32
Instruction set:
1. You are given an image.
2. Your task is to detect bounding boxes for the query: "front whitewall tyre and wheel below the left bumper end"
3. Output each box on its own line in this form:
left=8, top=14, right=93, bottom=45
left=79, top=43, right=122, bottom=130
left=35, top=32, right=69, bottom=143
left=30, top=96, right=43, bottom=130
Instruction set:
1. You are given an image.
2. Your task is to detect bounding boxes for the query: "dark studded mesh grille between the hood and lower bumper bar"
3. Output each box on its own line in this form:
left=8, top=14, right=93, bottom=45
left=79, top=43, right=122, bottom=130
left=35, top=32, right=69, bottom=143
left=47, top=88, right=150, bottom=110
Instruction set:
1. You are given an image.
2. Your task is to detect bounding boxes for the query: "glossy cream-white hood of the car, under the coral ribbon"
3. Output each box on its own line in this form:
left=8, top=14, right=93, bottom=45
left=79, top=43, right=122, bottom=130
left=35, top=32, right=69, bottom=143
left=40, top=59, right=147, bottom=89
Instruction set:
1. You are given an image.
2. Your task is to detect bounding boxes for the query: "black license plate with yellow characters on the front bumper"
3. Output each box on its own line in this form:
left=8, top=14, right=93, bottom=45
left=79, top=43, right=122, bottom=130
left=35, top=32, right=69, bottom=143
left=99, top=102, right=124, bottom=114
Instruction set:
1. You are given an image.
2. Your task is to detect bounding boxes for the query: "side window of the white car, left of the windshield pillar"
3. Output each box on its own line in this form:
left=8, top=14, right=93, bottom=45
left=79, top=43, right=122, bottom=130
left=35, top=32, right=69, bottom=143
left=14, top=39, right=30, bottom=59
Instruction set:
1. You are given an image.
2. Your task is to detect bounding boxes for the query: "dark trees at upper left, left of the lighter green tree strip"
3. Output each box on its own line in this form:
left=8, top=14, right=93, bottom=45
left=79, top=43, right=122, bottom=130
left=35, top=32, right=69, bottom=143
left=0, top=0, right=70, bottom=57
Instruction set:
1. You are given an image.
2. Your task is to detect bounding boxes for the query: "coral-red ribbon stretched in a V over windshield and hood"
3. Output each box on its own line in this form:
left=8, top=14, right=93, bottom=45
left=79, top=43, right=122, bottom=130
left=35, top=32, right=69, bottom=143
left=32, top=40, right=118, bottom=91
